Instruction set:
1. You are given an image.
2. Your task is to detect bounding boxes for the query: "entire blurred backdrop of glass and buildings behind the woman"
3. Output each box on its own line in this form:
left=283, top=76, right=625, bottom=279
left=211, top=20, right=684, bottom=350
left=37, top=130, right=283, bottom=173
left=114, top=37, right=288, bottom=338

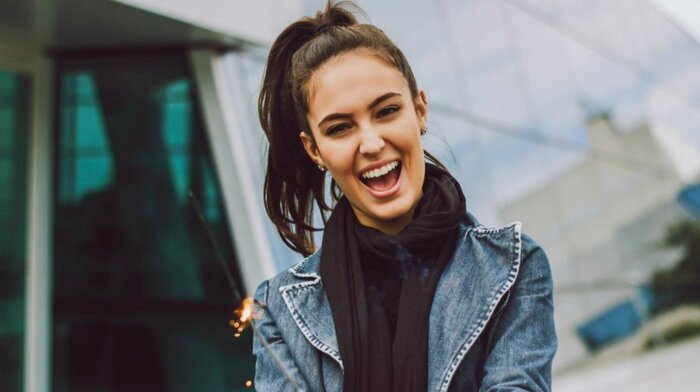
left=0, top=0, right=700, bottom=392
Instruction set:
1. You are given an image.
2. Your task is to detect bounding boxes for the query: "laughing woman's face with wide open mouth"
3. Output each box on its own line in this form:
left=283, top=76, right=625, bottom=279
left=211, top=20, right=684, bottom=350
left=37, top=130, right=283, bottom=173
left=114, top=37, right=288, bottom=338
left=300, top=49, right=427, bottom=235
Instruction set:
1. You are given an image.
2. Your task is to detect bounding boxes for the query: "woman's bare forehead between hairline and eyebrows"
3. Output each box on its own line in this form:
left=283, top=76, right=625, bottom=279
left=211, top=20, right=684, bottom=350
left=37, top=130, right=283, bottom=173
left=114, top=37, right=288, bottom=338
left=308, top=49, right=410, bottom=117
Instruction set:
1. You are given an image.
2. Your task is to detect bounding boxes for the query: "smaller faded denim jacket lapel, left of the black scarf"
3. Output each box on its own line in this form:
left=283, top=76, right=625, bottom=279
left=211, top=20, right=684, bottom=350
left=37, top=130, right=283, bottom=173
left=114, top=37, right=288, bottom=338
left=280, top=252, right=343, bottom=369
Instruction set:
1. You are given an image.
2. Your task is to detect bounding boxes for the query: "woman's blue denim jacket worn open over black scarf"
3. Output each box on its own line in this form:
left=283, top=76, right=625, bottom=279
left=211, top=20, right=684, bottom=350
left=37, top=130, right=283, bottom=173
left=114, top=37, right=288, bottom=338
left=253, top=214, right=557, bottom=392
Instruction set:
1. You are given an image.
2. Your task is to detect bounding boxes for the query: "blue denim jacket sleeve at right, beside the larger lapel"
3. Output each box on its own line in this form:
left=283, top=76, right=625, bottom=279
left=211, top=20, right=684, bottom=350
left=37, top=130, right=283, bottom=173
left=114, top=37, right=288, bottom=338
left=480, top=235, right=557, bottom=392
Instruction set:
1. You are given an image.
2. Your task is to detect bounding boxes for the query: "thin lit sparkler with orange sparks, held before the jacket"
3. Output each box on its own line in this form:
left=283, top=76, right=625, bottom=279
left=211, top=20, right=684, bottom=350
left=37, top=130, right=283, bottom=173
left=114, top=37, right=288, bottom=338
left=189, top=191, right=303, bottom=391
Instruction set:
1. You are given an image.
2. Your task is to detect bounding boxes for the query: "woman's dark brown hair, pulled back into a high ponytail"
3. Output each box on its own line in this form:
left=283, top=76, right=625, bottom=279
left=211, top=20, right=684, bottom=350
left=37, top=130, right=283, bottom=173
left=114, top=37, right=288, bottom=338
left=258, top=1, right=444, bottom=256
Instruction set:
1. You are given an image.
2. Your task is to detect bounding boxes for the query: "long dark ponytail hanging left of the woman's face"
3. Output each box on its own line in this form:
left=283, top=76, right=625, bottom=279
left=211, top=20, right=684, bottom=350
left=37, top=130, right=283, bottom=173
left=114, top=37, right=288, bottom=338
left=258, top=16, right=330, bottom=255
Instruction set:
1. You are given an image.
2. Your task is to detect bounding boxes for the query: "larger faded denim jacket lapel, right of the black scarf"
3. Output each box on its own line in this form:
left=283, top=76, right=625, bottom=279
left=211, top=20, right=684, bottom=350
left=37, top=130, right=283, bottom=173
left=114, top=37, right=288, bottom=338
left=428, top=223, right=521, bottom=391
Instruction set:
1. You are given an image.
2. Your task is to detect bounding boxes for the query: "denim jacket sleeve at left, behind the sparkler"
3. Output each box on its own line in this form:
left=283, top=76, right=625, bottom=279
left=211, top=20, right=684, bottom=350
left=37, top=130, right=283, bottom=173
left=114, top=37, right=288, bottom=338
left=253, top=281, right=310, bottom=392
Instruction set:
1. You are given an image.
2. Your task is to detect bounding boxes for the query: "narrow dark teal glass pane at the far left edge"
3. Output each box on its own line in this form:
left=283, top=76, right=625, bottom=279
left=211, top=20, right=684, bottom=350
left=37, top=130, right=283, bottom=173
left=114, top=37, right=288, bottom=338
left=0, top=69, right=29, bottom=392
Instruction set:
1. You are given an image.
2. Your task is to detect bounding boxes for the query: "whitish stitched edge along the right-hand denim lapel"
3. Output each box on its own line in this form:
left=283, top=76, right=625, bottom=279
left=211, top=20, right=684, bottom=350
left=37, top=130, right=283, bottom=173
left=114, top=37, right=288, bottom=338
left=438, top=222, right=522, bottom=392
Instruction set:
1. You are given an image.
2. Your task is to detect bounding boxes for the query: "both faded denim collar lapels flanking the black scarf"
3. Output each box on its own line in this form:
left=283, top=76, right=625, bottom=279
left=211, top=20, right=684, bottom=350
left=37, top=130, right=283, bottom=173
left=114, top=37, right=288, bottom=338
left=280, top=214, right=521, bottom=391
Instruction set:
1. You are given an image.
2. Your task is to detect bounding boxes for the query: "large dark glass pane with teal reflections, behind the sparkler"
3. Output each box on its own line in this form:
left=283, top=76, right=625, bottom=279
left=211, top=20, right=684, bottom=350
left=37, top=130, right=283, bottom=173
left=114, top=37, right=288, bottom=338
left=52, top=54, right=253, bottom=391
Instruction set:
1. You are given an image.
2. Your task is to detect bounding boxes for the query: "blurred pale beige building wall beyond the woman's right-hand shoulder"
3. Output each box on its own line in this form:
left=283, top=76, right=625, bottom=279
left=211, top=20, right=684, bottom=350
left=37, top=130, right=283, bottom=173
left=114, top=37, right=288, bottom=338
left=500, top=116, right=685, bottom=369
